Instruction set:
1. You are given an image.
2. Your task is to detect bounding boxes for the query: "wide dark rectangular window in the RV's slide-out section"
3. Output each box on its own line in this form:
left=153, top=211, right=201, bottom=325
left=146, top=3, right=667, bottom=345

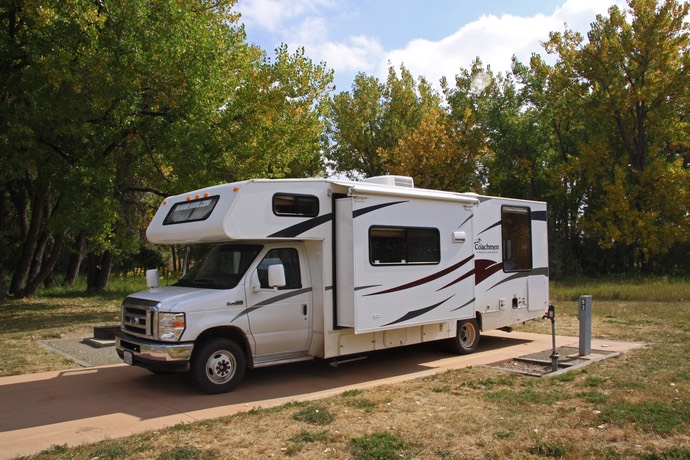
left=369, top=227, right=441, bottom=265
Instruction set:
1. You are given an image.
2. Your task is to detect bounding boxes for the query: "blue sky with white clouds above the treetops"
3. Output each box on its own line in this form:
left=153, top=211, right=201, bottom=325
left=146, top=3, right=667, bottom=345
left=236, top=0, right=625, bottom=92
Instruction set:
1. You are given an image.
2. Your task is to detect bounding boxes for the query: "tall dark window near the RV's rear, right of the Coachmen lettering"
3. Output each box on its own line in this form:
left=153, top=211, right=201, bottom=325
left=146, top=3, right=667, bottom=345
left=501, top=206, right=532, bottom=272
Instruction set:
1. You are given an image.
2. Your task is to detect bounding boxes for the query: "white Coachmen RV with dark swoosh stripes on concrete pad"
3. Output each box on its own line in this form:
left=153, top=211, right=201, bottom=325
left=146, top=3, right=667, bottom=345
left=116, top=176, right=549, bottom=393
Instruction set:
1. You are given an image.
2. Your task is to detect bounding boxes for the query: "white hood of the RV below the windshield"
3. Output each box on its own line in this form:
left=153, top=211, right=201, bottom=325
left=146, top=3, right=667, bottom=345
left=127, top=285, right=244, bottom=311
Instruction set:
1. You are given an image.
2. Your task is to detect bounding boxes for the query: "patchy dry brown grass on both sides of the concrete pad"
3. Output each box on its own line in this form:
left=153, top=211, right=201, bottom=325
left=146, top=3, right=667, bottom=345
left=0, top=280, right=690, bottom=460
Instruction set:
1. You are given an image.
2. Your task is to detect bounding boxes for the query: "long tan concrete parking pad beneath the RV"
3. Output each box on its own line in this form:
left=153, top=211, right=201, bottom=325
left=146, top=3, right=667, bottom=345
left=0, top=331, right=643, bottom=459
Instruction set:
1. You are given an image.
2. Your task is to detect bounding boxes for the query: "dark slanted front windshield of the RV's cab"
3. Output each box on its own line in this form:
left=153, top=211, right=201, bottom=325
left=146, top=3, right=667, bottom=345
left=175, top=244, right=261, bottom=289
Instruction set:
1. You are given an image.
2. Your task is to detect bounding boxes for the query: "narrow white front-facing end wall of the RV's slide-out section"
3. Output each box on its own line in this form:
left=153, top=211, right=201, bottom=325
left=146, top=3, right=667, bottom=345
left=333, top=198, right=355, bottom=327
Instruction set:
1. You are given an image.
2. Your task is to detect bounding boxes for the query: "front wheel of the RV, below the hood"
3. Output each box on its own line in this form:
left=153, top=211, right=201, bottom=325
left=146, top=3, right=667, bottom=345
left=191, top=338, right=247, bottom=394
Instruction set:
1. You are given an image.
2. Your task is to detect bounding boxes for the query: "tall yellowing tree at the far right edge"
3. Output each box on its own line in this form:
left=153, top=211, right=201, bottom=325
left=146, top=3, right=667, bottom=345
left=546, top=0, right=690, bottom=270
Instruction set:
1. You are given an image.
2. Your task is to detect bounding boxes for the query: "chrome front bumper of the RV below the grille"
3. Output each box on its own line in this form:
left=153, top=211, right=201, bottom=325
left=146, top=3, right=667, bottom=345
left=115, top=333, right=194, bottom=370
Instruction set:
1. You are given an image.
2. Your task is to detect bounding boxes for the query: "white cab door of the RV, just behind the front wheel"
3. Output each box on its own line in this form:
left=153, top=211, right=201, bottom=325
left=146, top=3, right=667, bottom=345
left=246, top=245, right=312, bottom=356
